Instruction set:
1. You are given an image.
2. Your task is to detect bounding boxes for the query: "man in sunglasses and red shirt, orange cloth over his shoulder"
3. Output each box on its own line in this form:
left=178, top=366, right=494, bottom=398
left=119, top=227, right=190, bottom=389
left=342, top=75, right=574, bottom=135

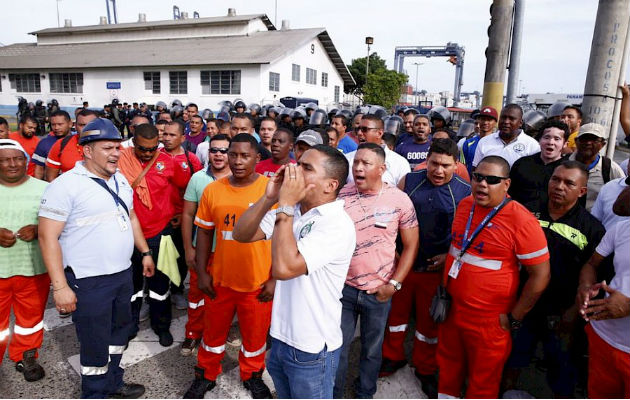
left=118, top=124, right=188, bottom=347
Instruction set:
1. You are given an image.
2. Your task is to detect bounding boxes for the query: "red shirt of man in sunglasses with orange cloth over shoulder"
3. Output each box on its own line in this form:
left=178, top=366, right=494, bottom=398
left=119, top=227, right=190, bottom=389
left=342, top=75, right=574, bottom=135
left=133, top=153, right=186, bottom=239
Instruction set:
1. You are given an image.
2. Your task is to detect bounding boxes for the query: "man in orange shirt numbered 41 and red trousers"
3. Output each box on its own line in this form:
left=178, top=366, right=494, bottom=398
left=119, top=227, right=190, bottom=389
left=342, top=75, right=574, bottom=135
left=184, top=133, right=275, bottom=399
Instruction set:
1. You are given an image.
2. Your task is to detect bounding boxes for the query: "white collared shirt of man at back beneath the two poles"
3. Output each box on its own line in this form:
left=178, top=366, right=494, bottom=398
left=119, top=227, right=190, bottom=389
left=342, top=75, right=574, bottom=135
left=473, top=130, right=540, bottom=167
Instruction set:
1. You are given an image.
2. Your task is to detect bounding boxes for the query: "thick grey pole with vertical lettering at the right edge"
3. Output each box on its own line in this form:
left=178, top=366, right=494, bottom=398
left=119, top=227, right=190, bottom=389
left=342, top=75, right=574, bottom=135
left=582, top=0, right=630, bottom=156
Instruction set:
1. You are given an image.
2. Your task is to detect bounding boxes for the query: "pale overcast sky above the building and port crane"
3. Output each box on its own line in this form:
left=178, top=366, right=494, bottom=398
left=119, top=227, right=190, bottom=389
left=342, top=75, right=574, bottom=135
left=0, top=0, right=598, bottom=93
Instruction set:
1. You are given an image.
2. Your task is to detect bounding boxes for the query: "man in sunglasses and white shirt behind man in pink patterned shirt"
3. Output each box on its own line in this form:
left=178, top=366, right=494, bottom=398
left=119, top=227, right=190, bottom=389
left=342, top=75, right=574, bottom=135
left=345, top=114, right=411, bottom=186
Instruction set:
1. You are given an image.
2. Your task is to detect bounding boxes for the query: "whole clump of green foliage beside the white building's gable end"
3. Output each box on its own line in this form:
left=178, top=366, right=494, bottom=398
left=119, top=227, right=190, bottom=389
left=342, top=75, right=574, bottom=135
left=346, top=53, right=407, bottom=108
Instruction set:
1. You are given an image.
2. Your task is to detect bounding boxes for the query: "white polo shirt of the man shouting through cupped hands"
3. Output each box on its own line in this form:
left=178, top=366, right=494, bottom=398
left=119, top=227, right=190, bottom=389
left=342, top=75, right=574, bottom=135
left=260, top=200, right=356, bottom=353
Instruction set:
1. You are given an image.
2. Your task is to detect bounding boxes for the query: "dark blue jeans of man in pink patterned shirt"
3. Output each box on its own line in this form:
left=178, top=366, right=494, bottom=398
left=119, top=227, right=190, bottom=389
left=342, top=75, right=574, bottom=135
left=334, top=285, right=392, bottom=399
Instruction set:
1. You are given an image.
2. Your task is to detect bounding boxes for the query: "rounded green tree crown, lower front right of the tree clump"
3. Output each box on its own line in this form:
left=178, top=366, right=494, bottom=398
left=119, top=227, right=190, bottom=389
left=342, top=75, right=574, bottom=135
left=363, top=69, right=407, bottom=109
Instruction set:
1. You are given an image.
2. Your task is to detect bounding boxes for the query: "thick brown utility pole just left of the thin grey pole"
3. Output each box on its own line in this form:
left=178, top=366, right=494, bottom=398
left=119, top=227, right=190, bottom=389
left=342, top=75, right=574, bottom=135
left=482, top=0, right=514, bottom=112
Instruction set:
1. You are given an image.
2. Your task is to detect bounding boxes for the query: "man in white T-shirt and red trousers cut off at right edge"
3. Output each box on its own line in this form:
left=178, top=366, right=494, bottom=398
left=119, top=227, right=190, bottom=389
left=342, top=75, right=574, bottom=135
left=577, top=187, right=630, bottom=398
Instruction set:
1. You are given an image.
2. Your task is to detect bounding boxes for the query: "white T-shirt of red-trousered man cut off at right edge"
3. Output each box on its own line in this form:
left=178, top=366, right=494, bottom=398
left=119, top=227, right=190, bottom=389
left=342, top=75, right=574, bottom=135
left=591, top=218, right=630, bottom=353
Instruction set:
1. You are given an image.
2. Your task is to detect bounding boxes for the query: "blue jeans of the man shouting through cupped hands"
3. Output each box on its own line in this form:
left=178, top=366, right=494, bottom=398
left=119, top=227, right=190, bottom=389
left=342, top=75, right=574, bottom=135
left=267, top=338, right=341, bottom=399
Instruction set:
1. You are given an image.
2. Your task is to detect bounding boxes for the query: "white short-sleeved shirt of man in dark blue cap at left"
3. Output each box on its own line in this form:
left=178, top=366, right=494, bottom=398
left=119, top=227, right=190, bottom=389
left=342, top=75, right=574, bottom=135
left=39, top=161, right=134, bottom=279
